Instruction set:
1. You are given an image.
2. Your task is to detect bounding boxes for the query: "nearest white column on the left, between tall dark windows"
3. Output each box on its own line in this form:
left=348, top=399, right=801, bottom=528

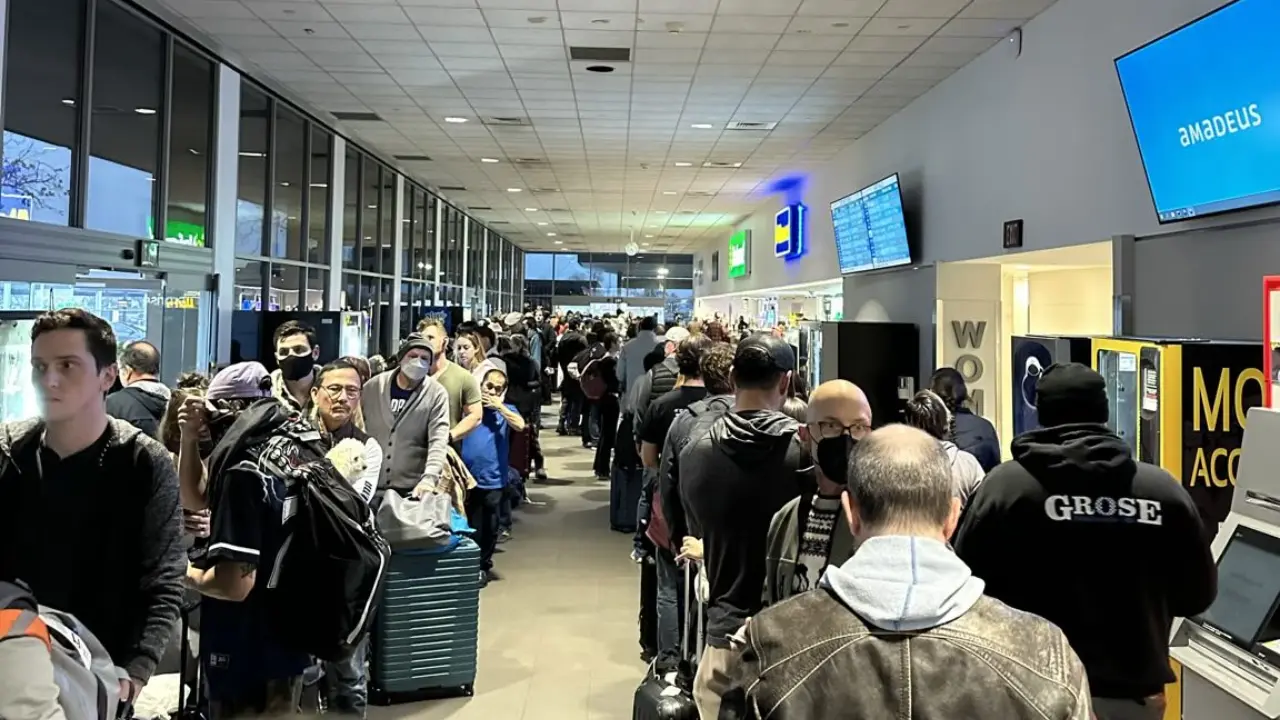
left=209, top=65, right=241, bottom=364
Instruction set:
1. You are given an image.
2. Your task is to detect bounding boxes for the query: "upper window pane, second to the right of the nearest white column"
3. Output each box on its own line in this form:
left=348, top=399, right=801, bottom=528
left=269, top=102, right=310, bottom=260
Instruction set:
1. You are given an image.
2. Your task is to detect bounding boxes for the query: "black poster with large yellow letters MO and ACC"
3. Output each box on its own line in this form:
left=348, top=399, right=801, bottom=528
left=1181, top=343, right=1263, bottom=532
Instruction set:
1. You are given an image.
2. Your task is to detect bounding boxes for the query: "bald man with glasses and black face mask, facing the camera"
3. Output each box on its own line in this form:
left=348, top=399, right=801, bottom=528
left=764, top=380, right=872, bottom=605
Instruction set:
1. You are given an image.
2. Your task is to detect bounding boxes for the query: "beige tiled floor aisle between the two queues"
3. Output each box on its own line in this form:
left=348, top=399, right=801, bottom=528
left=369, top=407, right=644, bottom=720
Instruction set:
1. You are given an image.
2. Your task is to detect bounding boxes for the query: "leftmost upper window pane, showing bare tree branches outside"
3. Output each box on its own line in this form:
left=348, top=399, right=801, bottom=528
left=0, top=0, right=84, bottom=225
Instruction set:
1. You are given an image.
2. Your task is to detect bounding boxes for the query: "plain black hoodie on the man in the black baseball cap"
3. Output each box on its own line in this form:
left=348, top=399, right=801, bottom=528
left=680, top=410, right=813, bottom=648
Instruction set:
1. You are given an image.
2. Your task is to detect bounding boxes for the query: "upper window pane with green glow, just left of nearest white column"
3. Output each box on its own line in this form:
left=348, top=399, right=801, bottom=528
left=165, top=42, right=214, bottom=247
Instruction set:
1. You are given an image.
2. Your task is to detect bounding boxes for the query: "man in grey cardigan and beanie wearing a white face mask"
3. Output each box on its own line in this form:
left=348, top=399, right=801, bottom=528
left=360, top=333, right=449, bottom=496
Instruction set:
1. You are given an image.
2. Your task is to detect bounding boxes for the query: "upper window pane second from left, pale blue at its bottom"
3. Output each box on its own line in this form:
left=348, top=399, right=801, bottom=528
left=85, top=3, right=164, bottom=237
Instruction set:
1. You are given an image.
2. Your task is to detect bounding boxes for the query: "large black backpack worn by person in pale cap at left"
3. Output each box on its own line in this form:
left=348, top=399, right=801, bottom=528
left=209, top=400, right=390, bottom=661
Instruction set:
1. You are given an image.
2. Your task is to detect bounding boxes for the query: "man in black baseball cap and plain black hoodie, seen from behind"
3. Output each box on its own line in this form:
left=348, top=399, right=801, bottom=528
left=680, top=333, right=814, bottom=717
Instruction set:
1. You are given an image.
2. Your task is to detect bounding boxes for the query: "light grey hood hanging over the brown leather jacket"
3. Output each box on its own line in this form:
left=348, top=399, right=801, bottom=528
left=820, top=536, right=986, bottom=632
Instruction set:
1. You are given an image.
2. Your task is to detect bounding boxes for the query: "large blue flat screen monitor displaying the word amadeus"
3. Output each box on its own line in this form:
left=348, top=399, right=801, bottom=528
left=1116, top=0, right=1280, bottom=223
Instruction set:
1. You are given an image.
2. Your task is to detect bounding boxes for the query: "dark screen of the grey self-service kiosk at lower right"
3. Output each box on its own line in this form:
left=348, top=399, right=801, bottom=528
left=1198, top=520, right=1280, bottom=650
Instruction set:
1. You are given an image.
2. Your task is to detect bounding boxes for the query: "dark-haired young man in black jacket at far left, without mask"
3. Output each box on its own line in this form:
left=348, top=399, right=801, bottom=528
left=0, top=307, right=186, bottom=701
